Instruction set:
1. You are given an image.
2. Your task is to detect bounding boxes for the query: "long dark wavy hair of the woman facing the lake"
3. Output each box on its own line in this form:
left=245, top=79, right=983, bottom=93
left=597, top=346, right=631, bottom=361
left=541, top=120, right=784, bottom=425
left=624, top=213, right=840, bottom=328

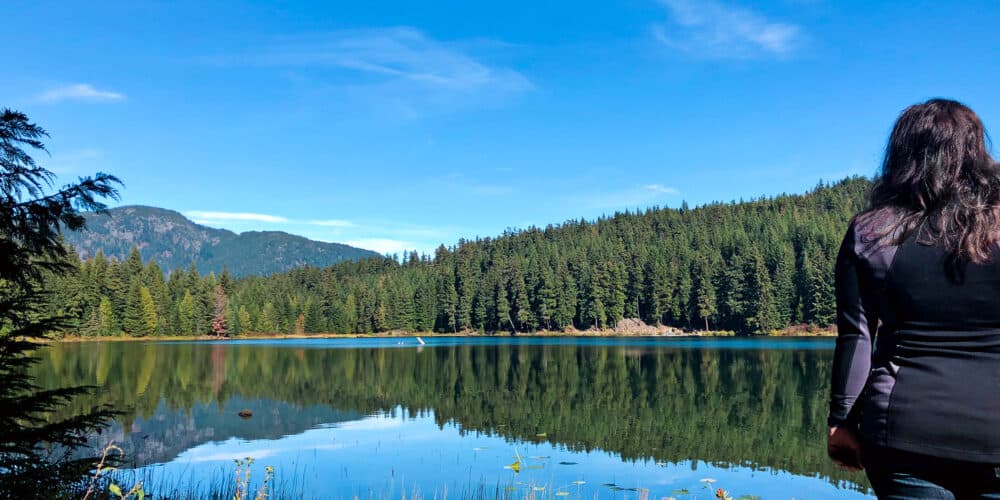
left=856, top=99, right=1000, bottom=263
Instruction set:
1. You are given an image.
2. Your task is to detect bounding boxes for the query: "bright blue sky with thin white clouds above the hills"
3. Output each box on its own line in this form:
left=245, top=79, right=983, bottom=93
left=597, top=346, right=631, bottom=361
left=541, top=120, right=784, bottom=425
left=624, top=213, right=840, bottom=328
left=0, top=0, right=1000, bottom=252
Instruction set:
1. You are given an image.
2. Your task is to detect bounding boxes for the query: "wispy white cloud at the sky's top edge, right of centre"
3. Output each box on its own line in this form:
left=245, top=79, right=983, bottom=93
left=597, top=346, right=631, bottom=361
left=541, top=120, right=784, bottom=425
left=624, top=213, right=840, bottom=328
left=653, top=0, right=804, bottom=59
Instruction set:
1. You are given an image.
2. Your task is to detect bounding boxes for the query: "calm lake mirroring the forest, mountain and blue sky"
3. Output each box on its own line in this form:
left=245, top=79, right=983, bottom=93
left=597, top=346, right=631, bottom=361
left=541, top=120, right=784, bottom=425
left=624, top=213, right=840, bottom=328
left=34, top=337, right=868, bottom=499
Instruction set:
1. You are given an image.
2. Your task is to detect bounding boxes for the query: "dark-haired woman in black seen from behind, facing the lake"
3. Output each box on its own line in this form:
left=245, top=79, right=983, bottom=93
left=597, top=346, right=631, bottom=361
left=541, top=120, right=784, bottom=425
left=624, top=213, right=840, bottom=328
left=827, top=99, right=1000, bottom=498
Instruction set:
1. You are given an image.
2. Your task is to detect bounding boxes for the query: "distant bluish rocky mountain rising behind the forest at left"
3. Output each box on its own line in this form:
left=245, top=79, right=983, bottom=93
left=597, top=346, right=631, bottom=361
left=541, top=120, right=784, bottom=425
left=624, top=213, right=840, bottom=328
left=65, top=205, right=379, bottom=276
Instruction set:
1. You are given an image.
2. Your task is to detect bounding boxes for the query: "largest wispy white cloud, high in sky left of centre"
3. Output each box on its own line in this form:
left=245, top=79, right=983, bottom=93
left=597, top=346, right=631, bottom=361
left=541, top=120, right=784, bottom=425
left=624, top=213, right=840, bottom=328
left=204, top=27, right=532, bottom=116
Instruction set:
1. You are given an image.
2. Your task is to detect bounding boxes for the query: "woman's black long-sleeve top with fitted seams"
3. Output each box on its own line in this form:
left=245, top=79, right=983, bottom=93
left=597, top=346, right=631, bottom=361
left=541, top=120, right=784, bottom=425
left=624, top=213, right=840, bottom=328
left=829, top=223, right=1000, bottom=464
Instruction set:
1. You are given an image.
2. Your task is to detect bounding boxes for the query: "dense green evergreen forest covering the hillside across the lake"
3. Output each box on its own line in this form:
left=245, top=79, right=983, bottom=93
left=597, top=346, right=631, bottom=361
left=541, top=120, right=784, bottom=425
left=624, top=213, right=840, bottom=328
left=46, top=177, right=870, bottom=336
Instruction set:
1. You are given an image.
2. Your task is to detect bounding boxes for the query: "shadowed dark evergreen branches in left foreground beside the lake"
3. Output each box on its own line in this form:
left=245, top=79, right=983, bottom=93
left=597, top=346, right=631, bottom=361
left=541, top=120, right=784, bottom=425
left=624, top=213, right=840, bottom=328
left=0, top=109, right=120, bottom=498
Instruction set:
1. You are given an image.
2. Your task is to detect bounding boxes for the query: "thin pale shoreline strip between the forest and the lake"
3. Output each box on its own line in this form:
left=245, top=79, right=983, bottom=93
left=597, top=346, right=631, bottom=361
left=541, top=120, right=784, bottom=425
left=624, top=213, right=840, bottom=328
left=54, top=328, right=837, bottom=343
